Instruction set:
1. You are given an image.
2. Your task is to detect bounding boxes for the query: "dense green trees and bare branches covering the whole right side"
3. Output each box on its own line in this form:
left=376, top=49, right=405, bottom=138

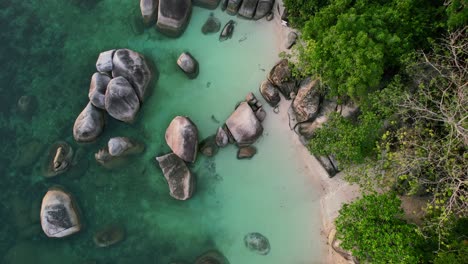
left=285, top=0, right=468, bottom=263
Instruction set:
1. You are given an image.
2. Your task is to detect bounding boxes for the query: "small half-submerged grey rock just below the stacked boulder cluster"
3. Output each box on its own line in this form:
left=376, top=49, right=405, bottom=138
left=94, top=137, right=145, bottom=169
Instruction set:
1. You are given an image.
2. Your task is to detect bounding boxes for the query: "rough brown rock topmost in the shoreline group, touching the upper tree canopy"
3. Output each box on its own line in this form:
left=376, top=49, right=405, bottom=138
left=268, top=59, right=297, bottom=100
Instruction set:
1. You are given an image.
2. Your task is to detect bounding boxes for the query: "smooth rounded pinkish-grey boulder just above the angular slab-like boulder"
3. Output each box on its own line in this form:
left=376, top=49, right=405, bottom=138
left=165, top=116, right=198, bottom=162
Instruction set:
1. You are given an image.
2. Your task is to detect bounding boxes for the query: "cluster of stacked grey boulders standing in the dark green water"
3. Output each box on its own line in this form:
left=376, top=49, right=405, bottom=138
left=73, top=49, right=153, bottom=142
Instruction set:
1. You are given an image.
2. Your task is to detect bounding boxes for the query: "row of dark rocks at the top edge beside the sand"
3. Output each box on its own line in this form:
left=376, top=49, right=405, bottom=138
left=221, top=0, right=275, bottom=20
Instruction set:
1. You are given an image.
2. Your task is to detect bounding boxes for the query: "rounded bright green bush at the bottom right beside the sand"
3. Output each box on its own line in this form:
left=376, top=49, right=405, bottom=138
left=335, top=194, right=425, bottom=263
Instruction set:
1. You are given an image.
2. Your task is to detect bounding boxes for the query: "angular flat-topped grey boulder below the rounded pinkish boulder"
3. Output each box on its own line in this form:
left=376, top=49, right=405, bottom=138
left=156, top=153, right=195, bottom=200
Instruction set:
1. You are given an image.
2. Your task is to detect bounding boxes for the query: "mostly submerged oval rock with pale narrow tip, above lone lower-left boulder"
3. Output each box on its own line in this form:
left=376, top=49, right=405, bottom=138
left=43, top=141, right=73, bottom=178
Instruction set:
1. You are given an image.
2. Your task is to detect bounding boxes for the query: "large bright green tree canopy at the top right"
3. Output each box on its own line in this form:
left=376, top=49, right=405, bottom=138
left=290, top=0, right=440, bottom=99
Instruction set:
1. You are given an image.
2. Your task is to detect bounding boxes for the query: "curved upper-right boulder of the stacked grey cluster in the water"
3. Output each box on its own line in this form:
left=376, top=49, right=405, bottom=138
left=112, top=49, right=152, bottom=102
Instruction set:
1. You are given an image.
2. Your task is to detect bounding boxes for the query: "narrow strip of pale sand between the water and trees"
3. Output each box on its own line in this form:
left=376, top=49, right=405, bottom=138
left=274, top=3, right=360, bottom=263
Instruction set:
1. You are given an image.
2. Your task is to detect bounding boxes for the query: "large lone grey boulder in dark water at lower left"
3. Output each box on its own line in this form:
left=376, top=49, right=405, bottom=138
left=40, top=187, right=81, bottom=238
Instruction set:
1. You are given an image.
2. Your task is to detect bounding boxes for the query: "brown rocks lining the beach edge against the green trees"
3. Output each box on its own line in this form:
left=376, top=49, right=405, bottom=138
left=260, top=59, right=359, bottom=177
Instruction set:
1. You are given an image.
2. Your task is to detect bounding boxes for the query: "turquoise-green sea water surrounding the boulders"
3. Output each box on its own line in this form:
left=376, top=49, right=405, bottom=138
left=0, top=0, right=322, bottom=264
